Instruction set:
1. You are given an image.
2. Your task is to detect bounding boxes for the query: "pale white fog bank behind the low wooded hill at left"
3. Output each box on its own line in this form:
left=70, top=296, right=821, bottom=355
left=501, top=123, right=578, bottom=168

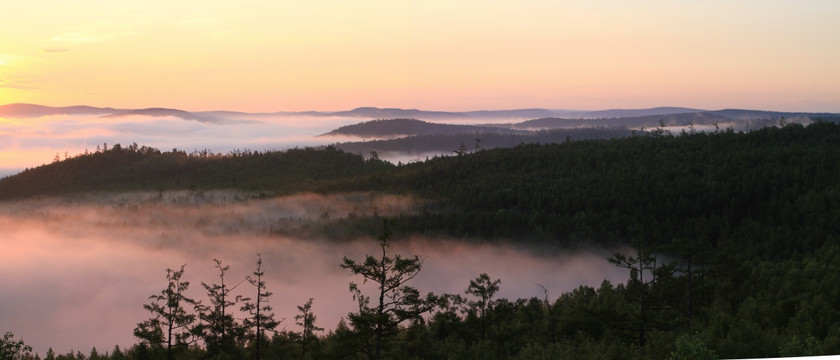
left=0, top=114, right=522, bottom=177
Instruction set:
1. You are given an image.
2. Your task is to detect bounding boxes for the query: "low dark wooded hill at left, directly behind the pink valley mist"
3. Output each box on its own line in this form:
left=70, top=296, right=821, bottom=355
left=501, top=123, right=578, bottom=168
left=0, top=144, right=393, bottom=199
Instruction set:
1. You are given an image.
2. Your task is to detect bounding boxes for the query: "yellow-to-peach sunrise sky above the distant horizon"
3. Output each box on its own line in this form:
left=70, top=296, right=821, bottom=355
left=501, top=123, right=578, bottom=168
left=0, top=0, right=840, bottom=112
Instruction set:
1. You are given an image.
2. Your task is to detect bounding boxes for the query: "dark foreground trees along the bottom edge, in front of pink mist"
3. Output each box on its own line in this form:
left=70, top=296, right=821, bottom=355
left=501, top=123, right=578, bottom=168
left=19, top=241, right=840, bottom=360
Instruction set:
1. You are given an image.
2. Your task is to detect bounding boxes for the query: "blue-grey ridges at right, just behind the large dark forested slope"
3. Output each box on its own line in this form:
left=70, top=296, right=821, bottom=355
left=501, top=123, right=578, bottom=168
left=321, top=108, right=840, bottom=159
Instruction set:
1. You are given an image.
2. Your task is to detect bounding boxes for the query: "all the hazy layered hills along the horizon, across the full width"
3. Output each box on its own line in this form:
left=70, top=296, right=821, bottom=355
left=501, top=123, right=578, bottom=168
left=6, top=104, right=840, bottom=161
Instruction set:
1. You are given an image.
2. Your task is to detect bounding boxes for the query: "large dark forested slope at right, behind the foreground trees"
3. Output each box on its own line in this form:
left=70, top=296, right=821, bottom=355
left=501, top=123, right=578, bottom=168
left=389, top=123, right=840, bottom=253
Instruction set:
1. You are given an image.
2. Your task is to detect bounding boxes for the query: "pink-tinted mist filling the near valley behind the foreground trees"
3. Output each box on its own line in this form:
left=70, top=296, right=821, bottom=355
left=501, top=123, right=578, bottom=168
left=0, top=191, right=627, bottom=355
